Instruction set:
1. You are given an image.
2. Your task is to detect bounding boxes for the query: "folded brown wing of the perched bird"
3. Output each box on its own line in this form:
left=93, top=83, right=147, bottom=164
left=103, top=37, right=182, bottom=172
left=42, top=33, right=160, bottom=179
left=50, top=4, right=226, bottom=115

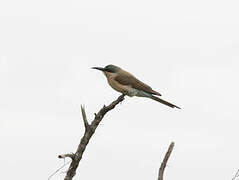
left=115, top=74, right=161, bottom=96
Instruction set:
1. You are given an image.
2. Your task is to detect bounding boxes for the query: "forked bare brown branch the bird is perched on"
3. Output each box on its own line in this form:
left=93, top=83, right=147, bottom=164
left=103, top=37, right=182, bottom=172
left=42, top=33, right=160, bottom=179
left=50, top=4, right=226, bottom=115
left=58, top=94, right=125, bottom=180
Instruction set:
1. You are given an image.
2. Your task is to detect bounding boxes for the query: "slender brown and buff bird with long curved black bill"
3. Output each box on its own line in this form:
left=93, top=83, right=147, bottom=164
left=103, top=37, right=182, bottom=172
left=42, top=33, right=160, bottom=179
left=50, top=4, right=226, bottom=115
left=92, top=64, right=181, bottom=109
